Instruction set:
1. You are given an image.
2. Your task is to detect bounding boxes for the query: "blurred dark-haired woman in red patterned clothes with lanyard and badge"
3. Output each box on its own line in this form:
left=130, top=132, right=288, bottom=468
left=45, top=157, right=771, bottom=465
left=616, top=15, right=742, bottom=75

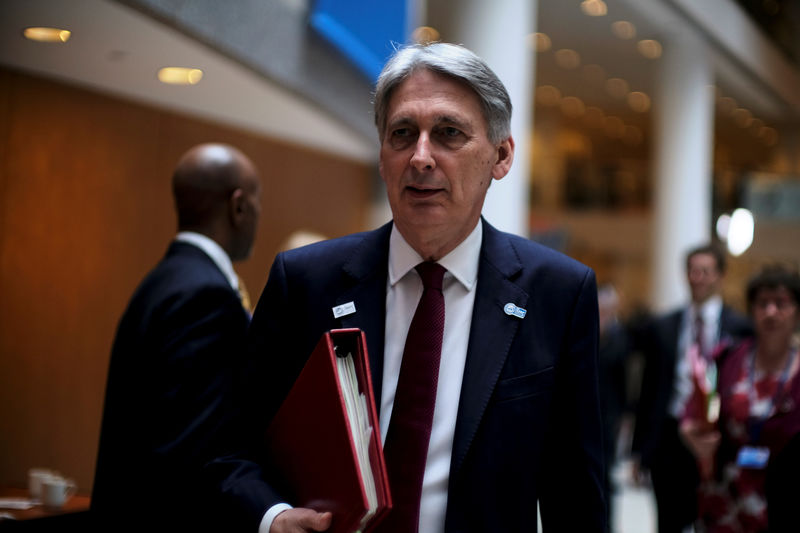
left=684, top=266, right=800, bottom=533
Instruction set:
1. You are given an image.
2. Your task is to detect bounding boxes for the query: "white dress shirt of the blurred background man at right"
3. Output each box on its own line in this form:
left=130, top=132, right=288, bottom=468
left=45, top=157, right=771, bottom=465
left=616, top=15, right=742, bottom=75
left=669, top=294, right=722, bottom=420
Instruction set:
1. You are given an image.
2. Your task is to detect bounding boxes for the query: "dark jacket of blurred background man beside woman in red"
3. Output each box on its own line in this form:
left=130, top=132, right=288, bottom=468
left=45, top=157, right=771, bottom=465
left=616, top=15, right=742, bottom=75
left=632, top=306, right=752, bottom=533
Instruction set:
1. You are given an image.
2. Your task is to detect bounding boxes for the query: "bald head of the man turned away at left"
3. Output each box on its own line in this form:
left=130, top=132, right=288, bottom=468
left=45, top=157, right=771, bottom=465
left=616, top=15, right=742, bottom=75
left=172, top=144, right=261, bottom=261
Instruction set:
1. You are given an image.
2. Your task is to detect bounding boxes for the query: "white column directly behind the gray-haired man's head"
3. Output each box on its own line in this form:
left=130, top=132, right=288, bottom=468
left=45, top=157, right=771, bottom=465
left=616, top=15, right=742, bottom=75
left=430, top=0, right=538, bottom=237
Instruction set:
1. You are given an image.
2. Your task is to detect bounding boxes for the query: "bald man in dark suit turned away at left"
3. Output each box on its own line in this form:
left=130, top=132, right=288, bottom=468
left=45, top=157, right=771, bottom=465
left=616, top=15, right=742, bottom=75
left=91, top=144, right=261, bottom=531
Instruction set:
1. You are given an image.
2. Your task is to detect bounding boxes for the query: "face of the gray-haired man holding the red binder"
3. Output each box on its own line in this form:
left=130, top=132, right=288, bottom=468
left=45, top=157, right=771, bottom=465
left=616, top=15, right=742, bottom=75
left=380, top=70, right=514, bottom=259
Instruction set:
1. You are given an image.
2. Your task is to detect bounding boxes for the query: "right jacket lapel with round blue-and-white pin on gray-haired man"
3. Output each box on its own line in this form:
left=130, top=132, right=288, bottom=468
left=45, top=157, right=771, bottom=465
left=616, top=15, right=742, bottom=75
left=450, top=220, right=528, bottom=474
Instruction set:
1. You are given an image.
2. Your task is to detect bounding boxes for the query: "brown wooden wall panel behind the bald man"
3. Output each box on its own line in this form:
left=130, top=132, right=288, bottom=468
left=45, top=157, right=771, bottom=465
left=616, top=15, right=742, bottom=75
left=0, top=70, right=371, bottom=491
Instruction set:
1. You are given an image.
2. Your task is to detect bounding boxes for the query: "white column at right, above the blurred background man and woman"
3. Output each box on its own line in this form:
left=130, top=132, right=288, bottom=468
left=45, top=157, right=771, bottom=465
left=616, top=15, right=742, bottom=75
left=651, top=34, right=714, bottom=311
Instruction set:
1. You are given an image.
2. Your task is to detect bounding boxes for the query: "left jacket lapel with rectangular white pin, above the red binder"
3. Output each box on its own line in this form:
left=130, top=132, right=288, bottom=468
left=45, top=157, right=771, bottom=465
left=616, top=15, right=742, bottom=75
left=336, top=222, right=392, bottom=405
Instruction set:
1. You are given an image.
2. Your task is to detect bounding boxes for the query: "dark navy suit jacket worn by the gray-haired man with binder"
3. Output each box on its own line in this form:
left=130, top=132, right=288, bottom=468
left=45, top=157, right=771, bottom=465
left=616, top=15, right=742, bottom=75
left=214, top=221, right=605, bottom=532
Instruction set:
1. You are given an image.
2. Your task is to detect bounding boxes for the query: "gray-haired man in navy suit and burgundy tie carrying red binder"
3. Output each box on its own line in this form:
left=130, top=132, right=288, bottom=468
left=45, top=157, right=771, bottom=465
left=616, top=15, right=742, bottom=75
left=213, top=43, right=605, bottom=533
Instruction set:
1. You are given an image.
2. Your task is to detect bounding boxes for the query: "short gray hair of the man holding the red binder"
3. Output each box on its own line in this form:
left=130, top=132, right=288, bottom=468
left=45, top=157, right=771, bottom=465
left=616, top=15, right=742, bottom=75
left=374, top=43, right=511, bottom=143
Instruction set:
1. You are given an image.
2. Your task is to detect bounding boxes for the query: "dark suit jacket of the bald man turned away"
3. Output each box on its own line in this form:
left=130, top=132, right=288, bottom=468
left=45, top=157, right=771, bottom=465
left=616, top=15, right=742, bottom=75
left=91, top=242, right=250, bottom=531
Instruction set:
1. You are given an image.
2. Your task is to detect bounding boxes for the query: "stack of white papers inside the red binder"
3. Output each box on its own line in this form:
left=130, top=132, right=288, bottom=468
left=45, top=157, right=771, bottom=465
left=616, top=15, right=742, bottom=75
left=336, top=353, right=378, bottom=529
